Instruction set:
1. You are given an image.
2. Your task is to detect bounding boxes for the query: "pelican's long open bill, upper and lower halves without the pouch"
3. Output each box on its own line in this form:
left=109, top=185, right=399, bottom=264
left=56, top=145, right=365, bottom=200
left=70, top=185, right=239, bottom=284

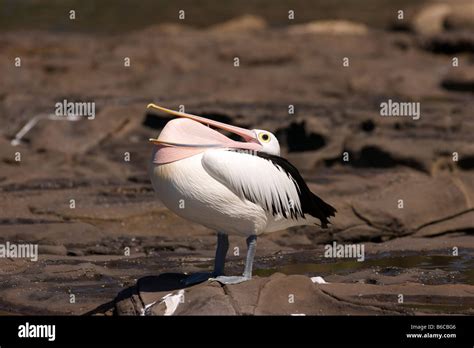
left=147, top=104, right=258, bottom=147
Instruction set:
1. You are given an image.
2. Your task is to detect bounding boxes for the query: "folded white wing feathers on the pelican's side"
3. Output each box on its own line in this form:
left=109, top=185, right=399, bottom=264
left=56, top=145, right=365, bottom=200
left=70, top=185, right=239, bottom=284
left=202, top=150, right=301, bottom=215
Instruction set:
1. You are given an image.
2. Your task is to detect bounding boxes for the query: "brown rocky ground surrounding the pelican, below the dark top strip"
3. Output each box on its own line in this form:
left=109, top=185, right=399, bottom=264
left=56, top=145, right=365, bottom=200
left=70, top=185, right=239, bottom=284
left=0, top=2, right=474, bottom=315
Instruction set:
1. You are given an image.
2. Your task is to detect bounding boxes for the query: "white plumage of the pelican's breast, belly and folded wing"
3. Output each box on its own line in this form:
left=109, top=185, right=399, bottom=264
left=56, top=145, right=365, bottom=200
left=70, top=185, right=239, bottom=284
left=150, top=149, right=315, bottom=236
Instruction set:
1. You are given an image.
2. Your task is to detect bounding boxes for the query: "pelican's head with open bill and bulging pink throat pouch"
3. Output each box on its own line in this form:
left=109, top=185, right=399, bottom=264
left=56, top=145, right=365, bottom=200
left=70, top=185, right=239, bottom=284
left=147, top=104, right=280, bottom=164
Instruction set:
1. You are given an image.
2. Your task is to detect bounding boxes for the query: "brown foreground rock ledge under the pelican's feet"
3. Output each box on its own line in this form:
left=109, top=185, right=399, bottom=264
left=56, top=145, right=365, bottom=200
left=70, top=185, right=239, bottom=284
left=109, top=273, right=474, bottom=315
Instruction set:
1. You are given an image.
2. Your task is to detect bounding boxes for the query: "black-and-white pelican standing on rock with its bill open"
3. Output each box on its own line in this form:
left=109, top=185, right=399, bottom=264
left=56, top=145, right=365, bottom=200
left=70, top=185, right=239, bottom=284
left=147, top=104, right=336, bottom=285
